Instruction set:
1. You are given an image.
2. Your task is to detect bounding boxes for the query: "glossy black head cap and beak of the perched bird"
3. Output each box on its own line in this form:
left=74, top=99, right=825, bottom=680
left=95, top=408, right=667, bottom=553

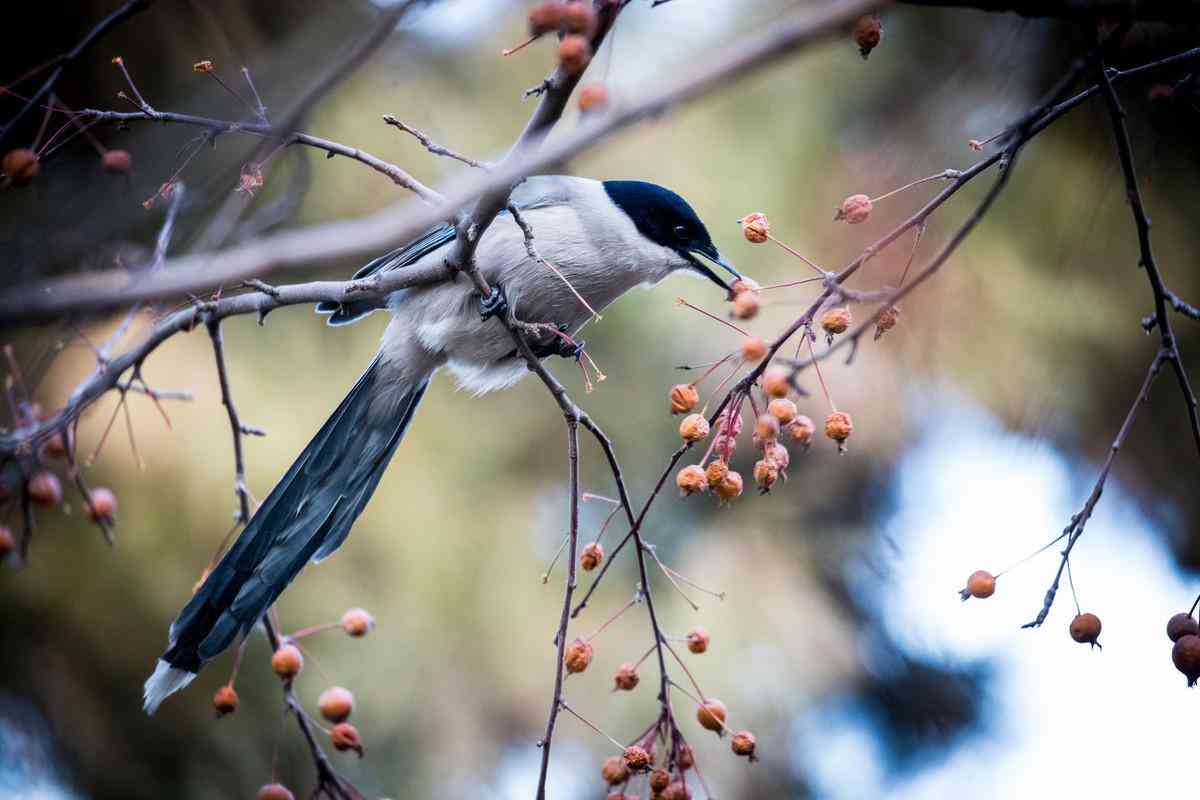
left=604, top=181, right=742, bottom=290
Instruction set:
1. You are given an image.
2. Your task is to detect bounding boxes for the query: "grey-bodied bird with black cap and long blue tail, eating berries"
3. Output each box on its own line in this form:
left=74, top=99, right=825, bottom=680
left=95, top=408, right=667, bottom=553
left=144, top=176, right=740, bottom=714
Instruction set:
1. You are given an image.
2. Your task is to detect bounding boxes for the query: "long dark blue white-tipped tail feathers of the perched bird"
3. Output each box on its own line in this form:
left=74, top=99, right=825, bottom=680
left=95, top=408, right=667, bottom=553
left=144, top=356, right=428, bottom=714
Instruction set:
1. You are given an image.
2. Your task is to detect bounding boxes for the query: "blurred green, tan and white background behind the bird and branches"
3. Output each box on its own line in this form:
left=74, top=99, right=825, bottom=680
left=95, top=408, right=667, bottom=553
left=0, top=0, right=1200, bottom=799
